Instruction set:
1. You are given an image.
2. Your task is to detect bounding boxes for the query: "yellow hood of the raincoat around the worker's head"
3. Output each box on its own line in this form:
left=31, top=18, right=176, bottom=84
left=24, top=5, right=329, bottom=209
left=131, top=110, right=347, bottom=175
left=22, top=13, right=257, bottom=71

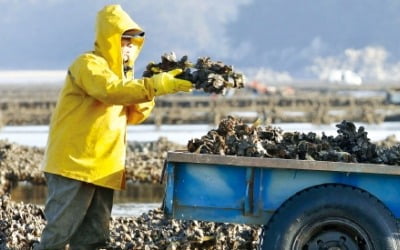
left=95, top=5, right=143, bottom=78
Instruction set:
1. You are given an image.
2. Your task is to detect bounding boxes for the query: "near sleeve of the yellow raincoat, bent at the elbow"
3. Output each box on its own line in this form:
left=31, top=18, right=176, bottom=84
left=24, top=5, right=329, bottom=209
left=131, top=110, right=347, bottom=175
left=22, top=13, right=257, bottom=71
left=70, top=54, right=154, bottom=106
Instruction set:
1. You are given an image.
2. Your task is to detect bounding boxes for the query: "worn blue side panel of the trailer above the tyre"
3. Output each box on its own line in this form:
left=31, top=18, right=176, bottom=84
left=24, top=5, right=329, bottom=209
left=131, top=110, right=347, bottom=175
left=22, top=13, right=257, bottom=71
left=165, top=162, right=400, bottom=224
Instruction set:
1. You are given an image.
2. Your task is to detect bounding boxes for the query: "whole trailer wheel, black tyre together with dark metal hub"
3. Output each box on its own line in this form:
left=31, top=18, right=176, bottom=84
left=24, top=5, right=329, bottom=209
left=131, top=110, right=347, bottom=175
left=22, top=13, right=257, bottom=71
left=261, top=184, right=400, bottom=250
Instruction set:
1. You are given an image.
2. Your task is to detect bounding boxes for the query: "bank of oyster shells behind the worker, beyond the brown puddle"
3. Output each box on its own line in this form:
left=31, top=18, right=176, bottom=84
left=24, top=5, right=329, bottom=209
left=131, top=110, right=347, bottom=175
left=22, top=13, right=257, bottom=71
left=0, top=137, right=185, bottom=195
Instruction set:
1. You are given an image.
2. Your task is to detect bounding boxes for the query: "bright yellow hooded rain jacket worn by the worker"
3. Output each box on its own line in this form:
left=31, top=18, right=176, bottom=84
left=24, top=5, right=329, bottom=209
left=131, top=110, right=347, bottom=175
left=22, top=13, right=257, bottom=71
left=43, top=5, right=154, bottom=190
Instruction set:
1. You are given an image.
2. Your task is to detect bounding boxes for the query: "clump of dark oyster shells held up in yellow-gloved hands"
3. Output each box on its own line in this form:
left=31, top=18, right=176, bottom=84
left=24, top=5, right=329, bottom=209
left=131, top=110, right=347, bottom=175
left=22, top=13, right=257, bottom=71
left=143, top=52, right=245, bottom=94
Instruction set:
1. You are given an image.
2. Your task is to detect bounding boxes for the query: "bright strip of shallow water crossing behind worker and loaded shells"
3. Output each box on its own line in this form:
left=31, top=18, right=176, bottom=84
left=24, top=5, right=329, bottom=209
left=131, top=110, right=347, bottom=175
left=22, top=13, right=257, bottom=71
left=0, top=122, right=400, bottom=147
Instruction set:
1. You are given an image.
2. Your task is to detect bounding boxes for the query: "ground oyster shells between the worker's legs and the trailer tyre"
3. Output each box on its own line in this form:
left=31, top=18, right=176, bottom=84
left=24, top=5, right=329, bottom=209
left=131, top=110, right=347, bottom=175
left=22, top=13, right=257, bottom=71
left=109, top=209, right=261, bottom=250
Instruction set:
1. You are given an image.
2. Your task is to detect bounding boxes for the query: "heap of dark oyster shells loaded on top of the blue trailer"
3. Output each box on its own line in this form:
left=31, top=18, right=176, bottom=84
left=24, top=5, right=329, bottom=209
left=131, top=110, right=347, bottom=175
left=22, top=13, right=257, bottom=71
left=187, top=116, right=400, bottom=165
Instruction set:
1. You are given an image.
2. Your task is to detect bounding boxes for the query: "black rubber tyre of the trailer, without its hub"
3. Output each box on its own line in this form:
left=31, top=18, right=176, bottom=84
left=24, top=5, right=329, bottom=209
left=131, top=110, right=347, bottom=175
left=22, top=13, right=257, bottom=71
left=261, top=184, right=400, bottom=250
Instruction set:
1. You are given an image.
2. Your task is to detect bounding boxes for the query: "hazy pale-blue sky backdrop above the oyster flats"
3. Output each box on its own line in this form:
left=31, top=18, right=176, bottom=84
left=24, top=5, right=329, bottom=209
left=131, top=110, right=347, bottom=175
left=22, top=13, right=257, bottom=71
left=0, top=0, right=400, bottom=81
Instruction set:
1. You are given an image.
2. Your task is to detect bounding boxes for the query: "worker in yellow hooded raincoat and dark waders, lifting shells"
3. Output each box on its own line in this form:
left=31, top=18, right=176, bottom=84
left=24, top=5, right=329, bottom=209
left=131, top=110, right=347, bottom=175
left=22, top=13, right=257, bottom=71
left=35, top=5, right=192, bottom=250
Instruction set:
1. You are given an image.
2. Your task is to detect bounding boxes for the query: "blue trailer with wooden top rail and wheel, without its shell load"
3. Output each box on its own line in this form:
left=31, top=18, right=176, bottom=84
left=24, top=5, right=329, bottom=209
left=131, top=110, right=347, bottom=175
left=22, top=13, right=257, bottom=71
left=164, top=152, right=400, bottom=250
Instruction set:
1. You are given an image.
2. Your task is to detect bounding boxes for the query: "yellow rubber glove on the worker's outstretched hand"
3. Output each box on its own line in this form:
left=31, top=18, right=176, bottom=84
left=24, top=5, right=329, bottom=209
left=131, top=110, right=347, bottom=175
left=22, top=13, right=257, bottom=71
left=151, top=69, right=193, bottom=96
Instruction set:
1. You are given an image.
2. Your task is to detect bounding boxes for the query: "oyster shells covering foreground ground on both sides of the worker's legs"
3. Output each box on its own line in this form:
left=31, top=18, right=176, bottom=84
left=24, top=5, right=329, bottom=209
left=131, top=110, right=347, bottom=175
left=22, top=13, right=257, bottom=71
left=0, top=195, right=261, bottom=250
